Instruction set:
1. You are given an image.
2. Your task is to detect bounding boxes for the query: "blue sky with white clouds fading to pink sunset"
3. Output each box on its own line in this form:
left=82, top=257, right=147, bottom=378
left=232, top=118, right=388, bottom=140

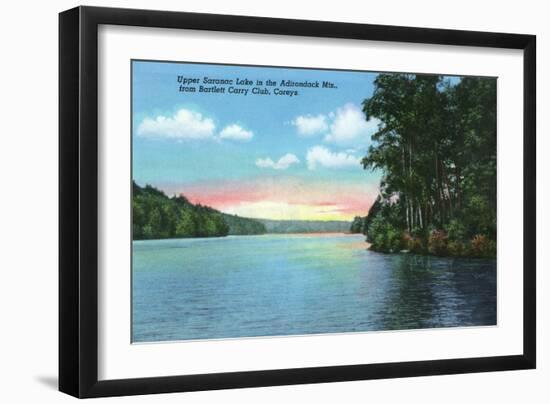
left=132, top=61, right=380, bottom=220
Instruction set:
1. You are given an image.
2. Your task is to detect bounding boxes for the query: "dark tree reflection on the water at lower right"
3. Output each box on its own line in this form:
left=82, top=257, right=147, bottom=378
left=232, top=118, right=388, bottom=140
left=382, top=255, right=496, bottom=329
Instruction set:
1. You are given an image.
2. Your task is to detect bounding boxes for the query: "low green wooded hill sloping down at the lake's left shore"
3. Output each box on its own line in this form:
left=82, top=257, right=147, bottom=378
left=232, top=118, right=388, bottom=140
left=132, top=182, right=265, bottom=240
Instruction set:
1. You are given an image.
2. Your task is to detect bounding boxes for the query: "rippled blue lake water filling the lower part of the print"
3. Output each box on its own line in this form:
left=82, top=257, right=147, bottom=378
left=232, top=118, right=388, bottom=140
left=132, top=234, right=496, bottom=342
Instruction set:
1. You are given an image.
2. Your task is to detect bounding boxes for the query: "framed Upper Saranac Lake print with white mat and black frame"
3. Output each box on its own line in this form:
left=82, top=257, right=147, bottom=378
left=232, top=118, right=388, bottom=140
left=59, top=7, right=536, bottom=397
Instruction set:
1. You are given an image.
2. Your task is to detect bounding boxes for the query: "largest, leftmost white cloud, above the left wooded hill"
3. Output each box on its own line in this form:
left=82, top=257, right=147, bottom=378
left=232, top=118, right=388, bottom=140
left=137, top=109, right=216, bottom=140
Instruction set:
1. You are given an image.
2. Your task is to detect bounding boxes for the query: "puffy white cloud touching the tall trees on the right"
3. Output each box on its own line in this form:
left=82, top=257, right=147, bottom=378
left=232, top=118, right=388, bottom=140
left=324, top=103, right=380, bottom=146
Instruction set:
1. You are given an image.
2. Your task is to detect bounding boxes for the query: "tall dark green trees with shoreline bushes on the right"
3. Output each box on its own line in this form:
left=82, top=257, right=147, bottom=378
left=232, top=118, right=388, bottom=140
left=358, top=74, right=497, bottom=257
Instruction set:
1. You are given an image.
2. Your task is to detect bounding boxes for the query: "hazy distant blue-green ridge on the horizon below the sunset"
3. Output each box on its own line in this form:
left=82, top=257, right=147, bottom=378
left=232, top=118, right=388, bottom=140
left=256, top=219, right=351, bottom=233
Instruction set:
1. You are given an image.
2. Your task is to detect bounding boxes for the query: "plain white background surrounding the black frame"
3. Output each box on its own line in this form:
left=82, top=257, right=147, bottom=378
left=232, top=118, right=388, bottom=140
left=0, top=0, right=550, bottom=404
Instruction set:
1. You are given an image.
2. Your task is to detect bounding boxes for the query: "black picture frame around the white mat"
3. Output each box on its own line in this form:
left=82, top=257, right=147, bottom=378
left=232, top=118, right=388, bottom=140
left=59, top=7, right=536, bottom=398
